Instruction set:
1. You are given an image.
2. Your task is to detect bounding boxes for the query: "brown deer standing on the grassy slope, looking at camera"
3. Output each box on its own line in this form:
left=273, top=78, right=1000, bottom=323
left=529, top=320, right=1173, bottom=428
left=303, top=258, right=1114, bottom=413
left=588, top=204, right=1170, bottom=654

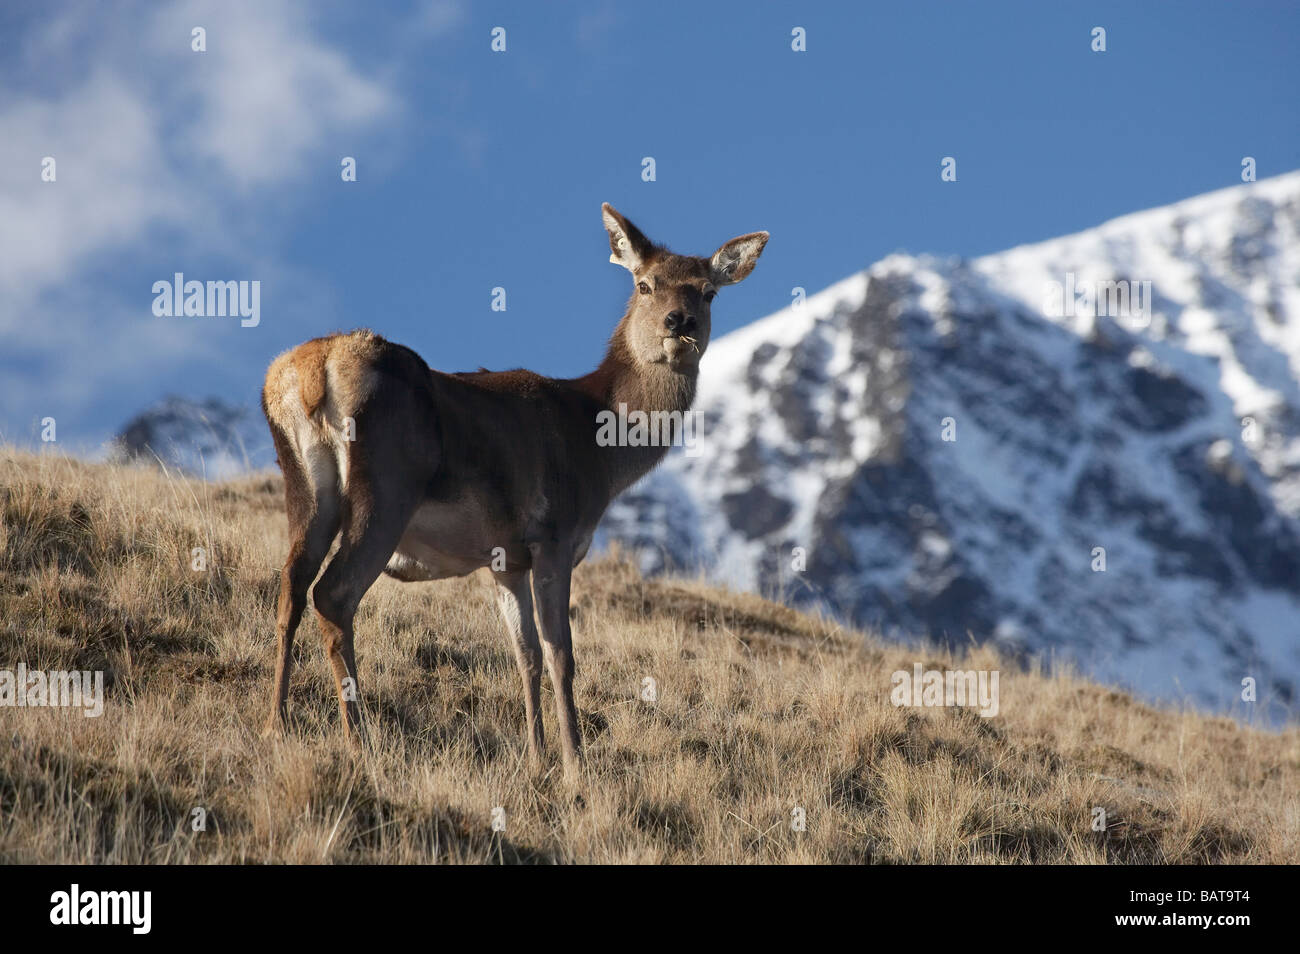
left=261, top=203, right=768, bottom=781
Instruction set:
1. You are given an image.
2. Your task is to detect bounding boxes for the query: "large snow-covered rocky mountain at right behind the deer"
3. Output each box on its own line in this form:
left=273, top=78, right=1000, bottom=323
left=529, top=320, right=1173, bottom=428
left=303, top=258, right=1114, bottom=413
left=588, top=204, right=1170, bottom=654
left=601, top=173, right=1300, bottom=719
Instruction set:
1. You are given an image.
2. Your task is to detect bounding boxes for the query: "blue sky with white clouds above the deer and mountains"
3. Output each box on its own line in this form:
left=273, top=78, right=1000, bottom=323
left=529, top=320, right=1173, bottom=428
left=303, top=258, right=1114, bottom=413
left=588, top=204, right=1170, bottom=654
left=0, top=0, right=1300, bottom=460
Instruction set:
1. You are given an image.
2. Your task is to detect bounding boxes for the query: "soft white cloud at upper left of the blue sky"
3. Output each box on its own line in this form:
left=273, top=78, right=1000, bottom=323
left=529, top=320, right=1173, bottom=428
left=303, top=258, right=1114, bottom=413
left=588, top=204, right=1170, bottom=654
left=0, top=0, right=410, bottom=437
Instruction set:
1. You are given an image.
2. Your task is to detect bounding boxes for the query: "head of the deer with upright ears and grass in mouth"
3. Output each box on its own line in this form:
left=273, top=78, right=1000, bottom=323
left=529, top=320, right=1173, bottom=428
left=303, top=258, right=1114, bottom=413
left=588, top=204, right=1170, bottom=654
left=601, top=203, right=767, bottom=374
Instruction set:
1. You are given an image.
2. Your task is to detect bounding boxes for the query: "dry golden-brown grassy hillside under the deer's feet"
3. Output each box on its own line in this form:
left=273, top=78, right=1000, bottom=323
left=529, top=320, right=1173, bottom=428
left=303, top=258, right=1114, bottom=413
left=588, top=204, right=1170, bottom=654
left=0, top=450, right=1300, bottom=863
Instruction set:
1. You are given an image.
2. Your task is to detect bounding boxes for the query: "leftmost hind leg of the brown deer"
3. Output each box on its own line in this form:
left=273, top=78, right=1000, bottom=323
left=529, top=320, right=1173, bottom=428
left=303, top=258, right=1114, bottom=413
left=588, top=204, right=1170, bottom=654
left=263, top=426, right=341, bottom=736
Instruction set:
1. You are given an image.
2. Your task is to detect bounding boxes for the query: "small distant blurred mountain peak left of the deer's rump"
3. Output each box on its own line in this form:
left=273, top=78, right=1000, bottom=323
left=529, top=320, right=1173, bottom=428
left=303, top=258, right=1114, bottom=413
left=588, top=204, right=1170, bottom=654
left=113, top=395, right=276, bottom=480
